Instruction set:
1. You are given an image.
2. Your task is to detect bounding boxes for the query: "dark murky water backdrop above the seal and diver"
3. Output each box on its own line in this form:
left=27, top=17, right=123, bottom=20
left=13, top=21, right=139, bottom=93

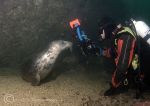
left=0, top=0, right=150, bottom=77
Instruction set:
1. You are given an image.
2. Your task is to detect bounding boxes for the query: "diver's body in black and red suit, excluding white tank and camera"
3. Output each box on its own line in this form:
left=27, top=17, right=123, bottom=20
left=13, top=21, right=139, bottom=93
left=98, top=17, right=146, bottom=98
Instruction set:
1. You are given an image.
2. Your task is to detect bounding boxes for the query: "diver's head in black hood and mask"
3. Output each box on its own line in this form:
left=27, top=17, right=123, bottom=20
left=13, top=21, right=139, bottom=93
left=98, top=17, right=117, bottom=41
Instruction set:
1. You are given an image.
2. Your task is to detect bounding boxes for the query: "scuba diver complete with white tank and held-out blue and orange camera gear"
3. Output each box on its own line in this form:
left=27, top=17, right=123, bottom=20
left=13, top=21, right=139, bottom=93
left=70, top=17, right=150, bottom=98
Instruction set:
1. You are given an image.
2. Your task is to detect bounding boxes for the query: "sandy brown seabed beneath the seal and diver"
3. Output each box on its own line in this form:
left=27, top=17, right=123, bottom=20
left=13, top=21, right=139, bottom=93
left=0, top=68, right=150, bottom=106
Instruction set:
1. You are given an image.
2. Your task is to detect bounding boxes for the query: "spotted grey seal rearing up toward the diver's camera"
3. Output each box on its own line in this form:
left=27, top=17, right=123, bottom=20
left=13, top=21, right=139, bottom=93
left=22, top=40, right=72, bottom=86
